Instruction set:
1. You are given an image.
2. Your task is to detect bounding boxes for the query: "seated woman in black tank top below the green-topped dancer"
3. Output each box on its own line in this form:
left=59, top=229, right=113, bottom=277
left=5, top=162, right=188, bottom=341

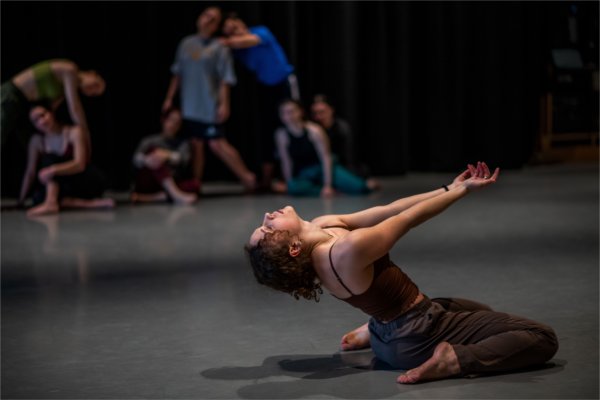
left=19, top=104, right=115, bottom=216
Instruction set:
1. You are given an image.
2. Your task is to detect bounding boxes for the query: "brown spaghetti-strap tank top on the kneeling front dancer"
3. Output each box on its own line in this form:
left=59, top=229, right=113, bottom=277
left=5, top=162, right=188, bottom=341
left=329, top=243, right=419, bottom=322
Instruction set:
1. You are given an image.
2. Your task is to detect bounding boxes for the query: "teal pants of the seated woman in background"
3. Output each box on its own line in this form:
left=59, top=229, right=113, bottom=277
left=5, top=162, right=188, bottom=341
left=287, top=163, right=371, bottom=196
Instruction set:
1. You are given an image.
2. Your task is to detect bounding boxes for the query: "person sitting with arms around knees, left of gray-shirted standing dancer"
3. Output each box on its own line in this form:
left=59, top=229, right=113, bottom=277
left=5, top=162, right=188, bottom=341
left=131, top=108, right=200, bottom=204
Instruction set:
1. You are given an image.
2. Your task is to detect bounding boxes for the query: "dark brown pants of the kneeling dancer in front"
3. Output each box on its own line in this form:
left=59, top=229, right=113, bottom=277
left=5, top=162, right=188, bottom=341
left=369, top=298, right=558, bottom=375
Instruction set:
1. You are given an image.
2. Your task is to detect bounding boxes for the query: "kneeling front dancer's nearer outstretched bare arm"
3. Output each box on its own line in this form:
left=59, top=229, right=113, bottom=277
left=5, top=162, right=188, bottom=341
left=336, top=163, right=500, bottom=268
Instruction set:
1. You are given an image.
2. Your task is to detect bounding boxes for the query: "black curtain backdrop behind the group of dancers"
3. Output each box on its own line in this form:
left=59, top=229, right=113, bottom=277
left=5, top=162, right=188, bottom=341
left=0, top=1, right=598, bottom=196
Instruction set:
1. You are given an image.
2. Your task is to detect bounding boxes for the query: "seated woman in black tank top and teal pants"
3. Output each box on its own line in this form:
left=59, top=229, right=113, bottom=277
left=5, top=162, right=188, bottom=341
left=275, top=99, right=378, bottom=197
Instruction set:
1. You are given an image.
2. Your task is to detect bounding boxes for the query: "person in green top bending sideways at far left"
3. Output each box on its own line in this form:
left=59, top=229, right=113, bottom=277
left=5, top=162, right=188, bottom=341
left=1, top=59, right=106, bottom=159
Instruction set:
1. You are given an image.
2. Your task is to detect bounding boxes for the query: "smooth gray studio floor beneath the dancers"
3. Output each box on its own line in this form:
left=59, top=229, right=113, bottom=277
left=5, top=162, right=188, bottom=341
left=1, top=165, right=599, bottom=399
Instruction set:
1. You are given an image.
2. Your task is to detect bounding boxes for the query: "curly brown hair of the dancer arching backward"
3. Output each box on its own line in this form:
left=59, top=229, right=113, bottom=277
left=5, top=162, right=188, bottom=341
left=244, top=231, right=323, bottom=302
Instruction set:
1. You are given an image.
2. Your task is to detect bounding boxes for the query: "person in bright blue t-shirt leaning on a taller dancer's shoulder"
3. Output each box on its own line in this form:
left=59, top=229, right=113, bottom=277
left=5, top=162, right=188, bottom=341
left=221, top=13, right=300, bottom=190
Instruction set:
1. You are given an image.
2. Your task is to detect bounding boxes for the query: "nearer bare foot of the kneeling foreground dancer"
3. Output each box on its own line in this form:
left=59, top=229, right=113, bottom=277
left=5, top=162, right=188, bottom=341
left=396, top=342, right=460, bottom=383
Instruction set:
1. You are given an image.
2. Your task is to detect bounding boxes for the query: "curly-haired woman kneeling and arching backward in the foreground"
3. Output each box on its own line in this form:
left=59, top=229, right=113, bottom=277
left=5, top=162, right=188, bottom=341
left=245, top=163, right=558, bottom=384
